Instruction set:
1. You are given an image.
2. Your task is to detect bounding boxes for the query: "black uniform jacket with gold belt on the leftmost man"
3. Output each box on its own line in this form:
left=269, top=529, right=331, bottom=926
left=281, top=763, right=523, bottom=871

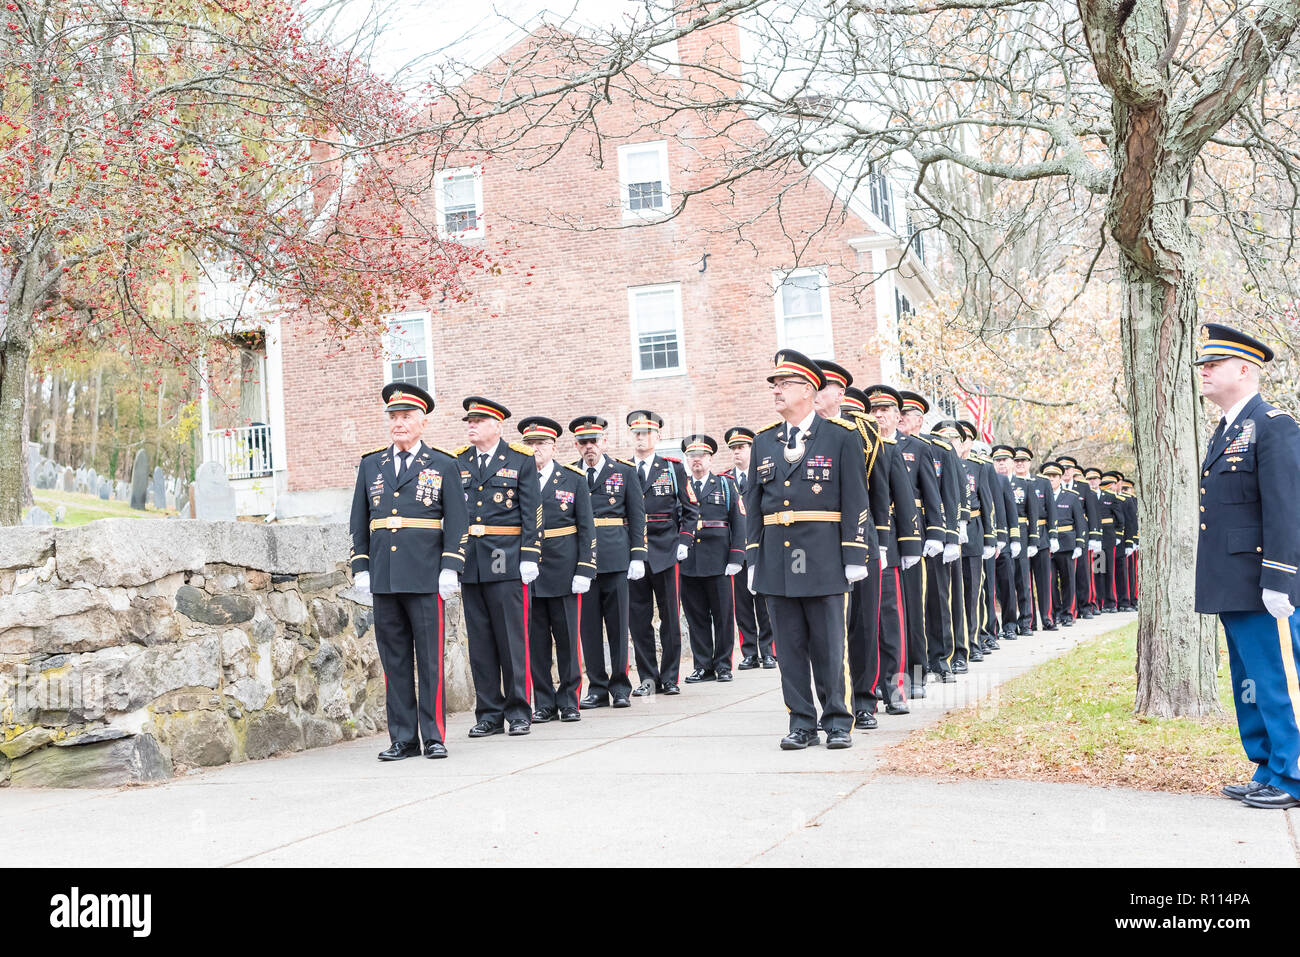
left=348, top=443, right=467, bottom=594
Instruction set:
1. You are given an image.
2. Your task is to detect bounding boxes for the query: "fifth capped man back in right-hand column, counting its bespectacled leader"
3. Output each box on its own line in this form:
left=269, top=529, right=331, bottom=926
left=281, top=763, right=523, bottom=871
left=898, top=389, right=957, bottom=698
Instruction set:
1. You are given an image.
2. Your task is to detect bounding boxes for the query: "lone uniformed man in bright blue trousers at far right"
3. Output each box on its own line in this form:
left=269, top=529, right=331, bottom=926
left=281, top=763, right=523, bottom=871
left=1196, top=322, right=1300, bottom=807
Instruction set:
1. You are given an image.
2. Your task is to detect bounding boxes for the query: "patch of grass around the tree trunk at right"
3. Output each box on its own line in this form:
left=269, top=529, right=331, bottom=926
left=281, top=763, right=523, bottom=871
left=887, top=624, right=1255, bottom=793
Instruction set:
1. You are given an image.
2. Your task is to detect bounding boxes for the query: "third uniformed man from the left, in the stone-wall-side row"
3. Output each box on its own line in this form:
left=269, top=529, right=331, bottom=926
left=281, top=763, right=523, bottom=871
left=519, top=415, right=595, bottom=724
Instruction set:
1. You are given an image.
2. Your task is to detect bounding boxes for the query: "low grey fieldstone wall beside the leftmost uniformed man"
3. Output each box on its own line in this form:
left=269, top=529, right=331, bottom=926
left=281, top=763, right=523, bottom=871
left=0, top=519, right=473, bottom=787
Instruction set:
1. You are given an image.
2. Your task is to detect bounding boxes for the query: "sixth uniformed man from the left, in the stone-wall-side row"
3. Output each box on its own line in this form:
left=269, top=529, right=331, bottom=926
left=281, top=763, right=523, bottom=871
left=681, top=436, right=745, bottom=681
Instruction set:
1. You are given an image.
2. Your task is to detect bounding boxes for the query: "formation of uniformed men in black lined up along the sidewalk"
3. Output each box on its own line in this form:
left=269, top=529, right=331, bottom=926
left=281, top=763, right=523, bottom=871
left=352, top=350, right=1138, bottom=759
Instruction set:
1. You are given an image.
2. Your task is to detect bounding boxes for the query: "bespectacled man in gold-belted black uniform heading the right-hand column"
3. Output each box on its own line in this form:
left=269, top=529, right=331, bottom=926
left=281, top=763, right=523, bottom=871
left=745, top=350, right=872, bottom=750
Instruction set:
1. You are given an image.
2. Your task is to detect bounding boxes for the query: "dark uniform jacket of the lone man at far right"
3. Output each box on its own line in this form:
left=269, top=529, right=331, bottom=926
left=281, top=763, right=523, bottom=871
left=1196, top=395, right=1300, bottom=615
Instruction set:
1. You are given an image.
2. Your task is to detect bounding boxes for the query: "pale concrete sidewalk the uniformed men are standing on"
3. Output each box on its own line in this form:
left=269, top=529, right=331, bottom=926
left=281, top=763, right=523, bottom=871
left=0, top=615, right=1300, bottom=867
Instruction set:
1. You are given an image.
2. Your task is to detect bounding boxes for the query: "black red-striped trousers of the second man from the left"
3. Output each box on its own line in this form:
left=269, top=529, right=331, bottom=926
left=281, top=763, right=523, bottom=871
left=460, top=579, right=533, bottom=726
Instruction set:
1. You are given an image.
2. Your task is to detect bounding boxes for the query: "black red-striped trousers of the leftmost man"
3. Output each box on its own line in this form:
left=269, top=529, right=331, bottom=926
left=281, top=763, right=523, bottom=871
left=374, top=583, right=447, bottom=744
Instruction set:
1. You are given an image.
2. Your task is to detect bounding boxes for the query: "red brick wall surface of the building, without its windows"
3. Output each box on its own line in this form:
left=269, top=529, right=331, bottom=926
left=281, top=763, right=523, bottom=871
left=283, top=28, right=880, bottom=490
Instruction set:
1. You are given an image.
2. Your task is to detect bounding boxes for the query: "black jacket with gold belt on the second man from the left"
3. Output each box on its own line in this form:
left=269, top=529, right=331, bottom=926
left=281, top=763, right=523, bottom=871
left=456, top=441, right=542, bottom=585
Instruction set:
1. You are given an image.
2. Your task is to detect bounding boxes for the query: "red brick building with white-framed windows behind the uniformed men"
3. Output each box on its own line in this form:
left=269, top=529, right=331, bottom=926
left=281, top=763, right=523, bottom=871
left=197, top=18, right=933, bottom=518
